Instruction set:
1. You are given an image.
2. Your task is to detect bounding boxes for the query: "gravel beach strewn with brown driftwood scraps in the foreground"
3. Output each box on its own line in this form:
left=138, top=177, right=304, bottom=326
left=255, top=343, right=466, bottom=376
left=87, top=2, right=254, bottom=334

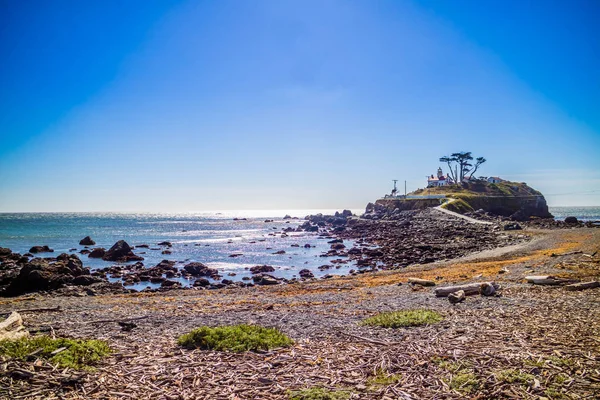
left=0, top=229, right=600, bottom=399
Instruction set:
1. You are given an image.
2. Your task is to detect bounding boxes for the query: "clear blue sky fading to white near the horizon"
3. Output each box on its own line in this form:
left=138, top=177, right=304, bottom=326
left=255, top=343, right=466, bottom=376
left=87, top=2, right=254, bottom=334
left=0, top=0, right=600, bottom=211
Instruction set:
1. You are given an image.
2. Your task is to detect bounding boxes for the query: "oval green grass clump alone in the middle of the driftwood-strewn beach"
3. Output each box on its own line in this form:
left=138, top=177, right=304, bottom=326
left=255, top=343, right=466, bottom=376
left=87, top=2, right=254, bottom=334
left=177, top=325, right=293, bottom=353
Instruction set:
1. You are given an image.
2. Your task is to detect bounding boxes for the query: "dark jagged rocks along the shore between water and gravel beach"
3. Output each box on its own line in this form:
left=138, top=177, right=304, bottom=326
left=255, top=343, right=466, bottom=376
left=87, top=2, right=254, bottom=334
left=0, top=206, right=528, bottom=296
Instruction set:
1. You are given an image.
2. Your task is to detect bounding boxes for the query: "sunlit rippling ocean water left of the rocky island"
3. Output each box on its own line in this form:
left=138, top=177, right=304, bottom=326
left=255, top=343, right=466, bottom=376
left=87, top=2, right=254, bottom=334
left=0, top=210, right=358, bottom=289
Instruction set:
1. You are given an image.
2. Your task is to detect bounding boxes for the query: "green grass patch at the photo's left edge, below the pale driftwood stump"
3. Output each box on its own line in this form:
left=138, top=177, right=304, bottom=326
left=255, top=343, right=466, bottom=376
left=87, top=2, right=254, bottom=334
left=0, top=336, right=111, bottom=370
